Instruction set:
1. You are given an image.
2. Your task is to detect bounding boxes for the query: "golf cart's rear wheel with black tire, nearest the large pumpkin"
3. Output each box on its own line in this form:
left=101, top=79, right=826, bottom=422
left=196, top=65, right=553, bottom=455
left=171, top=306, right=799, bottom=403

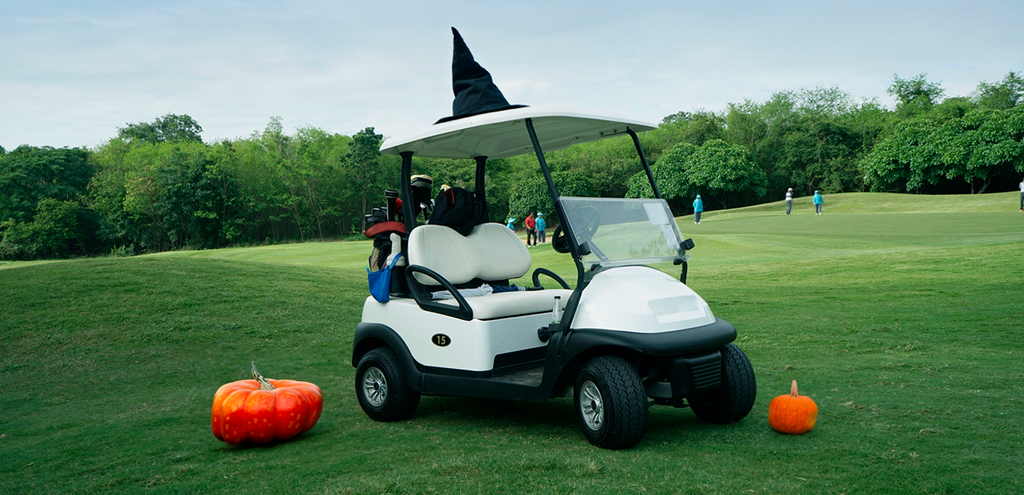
left=355, top=347, right=420, bottom=421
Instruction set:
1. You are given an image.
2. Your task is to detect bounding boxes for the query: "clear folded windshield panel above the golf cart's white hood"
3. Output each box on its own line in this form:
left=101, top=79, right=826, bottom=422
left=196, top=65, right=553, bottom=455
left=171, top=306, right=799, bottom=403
left=558, top=196, right=684, bottom=266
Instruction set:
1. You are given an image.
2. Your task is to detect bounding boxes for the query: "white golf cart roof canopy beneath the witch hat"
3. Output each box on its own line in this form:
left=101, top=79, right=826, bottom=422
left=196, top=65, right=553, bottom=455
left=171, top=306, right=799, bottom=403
left=381, top=107, right=657, bottom=159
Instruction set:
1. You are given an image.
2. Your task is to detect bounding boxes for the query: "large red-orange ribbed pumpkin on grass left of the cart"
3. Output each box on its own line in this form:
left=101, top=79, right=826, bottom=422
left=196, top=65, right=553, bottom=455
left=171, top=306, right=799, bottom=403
left=212, top=363, right=324, bottom=445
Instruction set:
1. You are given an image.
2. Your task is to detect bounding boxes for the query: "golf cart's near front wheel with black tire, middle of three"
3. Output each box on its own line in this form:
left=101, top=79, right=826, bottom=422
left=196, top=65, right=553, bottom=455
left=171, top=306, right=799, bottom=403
left=572, top=356, right=647, bottom=449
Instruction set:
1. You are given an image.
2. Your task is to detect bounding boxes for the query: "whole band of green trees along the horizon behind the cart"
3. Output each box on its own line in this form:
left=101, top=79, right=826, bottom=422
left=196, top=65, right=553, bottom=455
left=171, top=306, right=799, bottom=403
left=0, top=72, right=1024, bottom=259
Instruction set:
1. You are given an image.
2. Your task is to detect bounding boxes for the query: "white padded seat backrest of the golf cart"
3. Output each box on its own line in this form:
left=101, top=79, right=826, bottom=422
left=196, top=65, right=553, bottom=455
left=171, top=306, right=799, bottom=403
left=409, top=223, right=530, bottom=285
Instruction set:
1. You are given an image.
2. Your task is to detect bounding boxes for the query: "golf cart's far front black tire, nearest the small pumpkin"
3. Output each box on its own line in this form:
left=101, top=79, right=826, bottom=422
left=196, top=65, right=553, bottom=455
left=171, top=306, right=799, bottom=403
left=689, top=343, right=758, bottom=424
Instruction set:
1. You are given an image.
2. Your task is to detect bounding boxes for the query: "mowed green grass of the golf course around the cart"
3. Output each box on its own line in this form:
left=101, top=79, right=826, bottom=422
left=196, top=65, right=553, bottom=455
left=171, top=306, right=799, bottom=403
left=0, top=193, right=1024, bottom=493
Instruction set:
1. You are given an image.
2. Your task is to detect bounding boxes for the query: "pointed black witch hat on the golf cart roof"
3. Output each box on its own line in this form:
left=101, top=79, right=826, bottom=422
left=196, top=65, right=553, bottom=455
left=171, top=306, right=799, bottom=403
left=435, top=28, right=525, bottom=124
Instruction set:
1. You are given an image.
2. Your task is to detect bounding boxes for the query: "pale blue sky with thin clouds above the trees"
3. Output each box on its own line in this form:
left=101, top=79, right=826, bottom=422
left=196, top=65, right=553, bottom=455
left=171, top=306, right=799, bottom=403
left=0, top=0, right=1024, bottom=151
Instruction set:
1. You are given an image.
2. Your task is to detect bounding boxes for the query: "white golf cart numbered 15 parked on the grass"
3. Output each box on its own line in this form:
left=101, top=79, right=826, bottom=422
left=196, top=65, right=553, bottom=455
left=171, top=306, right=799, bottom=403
left=352, top=107, right=757, bottom=449
